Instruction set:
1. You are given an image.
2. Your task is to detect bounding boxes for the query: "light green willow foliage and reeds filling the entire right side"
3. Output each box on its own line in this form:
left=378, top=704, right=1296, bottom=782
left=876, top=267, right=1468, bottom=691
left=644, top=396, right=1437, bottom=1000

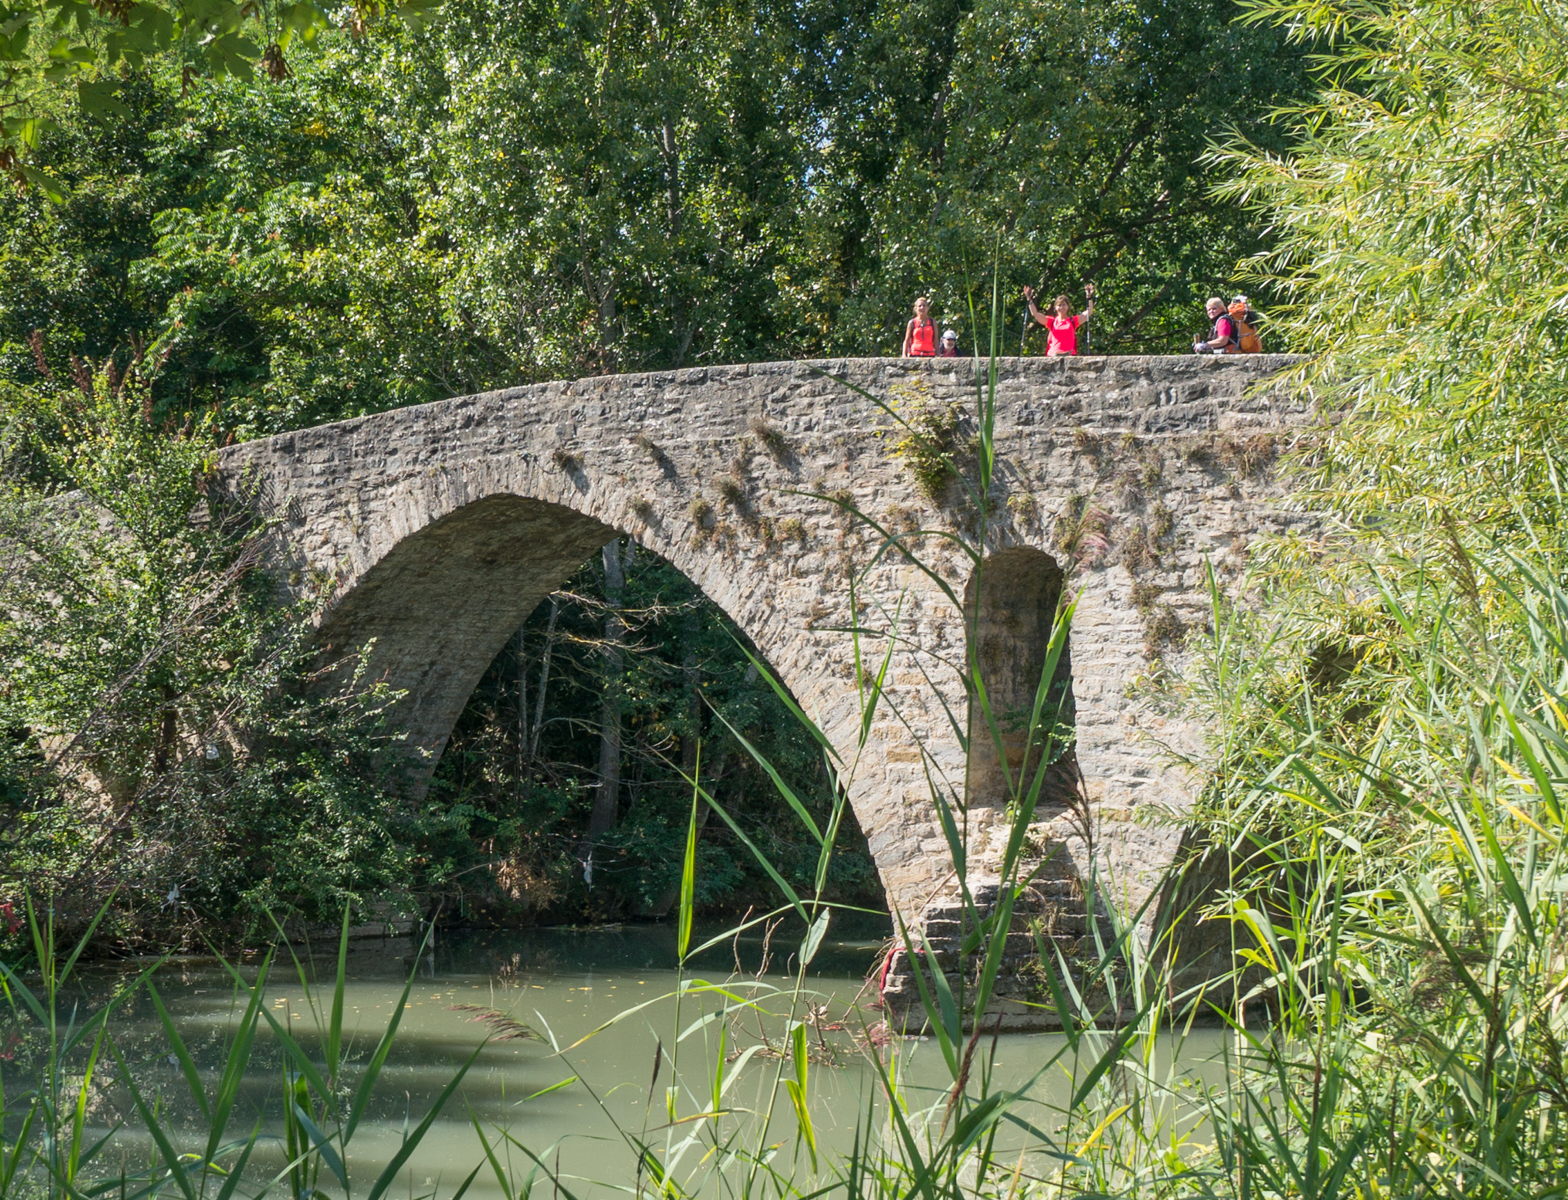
left=1160, top=0, right=1568, bottom=1195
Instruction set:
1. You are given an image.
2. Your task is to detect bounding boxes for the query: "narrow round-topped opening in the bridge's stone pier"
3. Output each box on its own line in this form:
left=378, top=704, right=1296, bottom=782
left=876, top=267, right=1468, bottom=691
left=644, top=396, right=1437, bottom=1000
left=964, top=546, right=1077, bottom=809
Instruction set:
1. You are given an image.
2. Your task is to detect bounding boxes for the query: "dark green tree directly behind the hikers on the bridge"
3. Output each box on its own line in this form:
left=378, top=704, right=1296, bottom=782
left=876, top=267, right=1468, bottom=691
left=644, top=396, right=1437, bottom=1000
left=817, top=0, right=1306, bottom=353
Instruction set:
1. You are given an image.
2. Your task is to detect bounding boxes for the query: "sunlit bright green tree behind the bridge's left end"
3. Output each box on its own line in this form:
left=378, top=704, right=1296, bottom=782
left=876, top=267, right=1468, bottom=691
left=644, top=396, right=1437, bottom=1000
left=0, top=39, right=505, bottom=438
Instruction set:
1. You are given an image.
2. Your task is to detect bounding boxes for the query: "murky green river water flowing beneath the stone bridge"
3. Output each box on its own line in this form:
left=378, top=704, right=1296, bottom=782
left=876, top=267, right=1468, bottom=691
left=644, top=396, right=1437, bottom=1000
left=64, top=925, right=1218, bottom=1200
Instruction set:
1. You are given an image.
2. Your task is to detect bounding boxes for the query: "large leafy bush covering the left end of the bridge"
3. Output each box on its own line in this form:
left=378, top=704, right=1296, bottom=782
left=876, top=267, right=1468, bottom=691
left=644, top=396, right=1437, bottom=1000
left=0, top=365, right=420, bottom=946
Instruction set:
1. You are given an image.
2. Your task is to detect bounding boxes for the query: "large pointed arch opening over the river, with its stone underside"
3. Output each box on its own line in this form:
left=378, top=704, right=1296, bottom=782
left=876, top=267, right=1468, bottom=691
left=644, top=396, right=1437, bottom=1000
left=323, top=494, right=886, bottom=922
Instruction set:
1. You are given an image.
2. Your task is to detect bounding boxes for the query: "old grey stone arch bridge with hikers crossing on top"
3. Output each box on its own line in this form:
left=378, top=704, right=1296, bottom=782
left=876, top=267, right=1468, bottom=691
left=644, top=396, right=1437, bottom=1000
left=220, top=356, right=1306, bottom=918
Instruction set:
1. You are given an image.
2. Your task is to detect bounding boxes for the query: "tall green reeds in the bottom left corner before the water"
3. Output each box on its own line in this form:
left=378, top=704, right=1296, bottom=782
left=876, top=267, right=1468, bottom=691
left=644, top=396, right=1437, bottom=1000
left=0, top=907, right=483, bottom=1200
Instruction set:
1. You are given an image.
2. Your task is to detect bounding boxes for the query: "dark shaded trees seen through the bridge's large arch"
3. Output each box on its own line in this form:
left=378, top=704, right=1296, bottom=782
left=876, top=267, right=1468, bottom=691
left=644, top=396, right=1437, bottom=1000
left=425, top=549, right=886, bottom=921
